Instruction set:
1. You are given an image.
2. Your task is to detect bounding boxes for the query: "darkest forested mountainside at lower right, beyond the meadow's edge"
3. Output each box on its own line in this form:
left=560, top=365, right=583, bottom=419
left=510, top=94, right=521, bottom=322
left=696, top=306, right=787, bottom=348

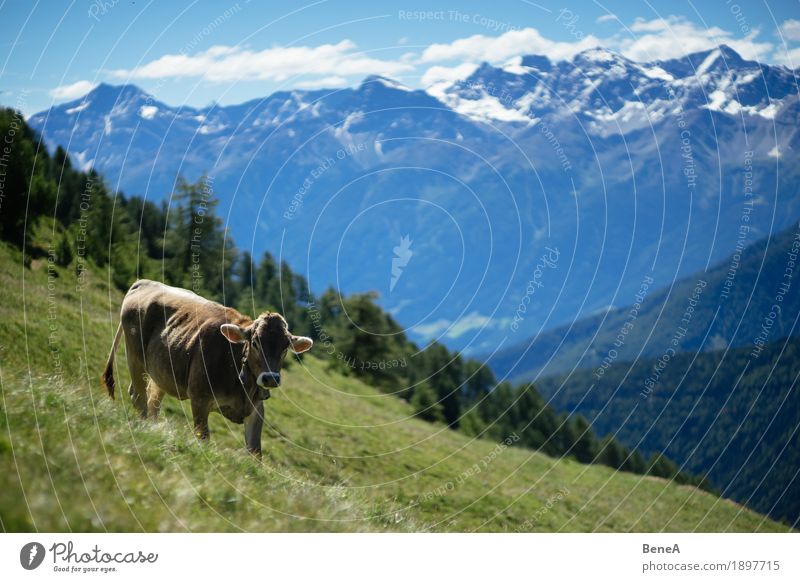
left=536, top=336, right=800, bottom=524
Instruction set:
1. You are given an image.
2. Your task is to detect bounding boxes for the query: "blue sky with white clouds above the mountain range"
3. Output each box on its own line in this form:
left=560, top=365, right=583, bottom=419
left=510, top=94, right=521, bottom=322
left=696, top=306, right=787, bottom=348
left=0, top=0, right=800, bottom=116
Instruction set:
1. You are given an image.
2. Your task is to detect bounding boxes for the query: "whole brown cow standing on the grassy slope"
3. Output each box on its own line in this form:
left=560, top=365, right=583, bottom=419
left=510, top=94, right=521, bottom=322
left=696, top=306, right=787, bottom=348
left=101, top=279, right=313, bottom=458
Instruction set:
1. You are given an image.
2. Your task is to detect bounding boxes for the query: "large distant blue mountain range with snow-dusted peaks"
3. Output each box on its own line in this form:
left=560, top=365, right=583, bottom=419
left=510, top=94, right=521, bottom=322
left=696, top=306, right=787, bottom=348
left=25, top=46, right=800, bottom=353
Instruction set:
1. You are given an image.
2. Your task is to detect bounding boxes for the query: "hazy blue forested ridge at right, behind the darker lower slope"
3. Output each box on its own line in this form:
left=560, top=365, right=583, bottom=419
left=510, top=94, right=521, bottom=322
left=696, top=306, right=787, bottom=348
left=489, top=223, right=800, bottom=380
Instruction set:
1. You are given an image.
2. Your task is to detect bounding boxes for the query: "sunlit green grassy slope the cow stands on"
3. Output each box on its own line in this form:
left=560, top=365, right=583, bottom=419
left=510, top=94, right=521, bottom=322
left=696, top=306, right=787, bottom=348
left=0, top=241, right=786, bottom=531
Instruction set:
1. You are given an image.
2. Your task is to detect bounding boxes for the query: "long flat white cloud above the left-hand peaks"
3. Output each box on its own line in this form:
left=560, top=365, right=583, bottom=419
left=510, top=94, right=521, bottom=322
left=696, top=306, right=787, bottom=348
left=114, top=40, right=413, bottom=82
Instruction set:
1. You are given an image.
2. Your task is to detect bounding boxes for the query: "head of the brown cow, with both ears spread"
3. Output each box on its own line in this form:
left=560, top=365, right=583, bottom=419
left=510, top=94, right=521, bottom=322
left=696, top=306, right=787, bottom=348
left=225, top=313, right=314, bottom=388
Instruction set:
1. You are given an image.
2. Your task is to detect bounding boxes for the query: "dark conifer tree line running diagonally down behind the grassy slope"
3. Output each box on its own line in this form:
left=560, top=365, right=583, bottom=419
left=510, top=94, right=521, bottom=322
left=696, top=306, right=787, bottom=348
left=0, top=109, right=706, bottom=486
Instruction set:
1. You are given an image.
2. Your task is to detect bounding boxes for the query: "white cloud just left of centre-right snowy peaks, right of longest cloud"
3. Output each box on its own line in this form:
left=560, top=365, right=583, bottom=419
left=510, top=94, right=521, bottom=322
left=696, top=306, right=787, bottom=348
left=419, top=28, right=600, bottom=63
